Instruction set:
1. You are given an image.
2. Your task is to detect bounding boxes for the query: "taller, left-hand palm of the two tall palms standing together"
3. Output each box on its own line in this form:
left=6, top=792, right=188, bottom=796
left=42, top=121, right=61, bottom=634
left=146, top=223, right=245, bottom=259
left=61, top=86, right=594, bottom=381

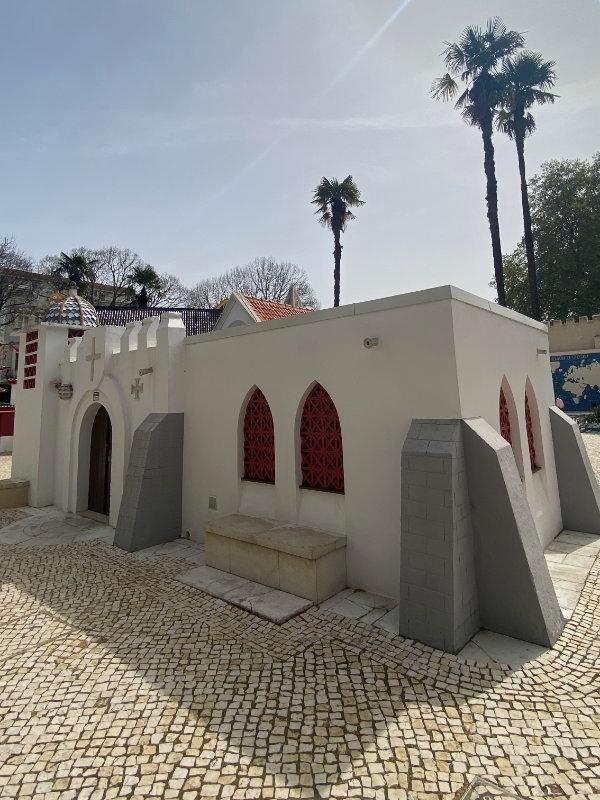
left=431, top=17, right=524, bottom=306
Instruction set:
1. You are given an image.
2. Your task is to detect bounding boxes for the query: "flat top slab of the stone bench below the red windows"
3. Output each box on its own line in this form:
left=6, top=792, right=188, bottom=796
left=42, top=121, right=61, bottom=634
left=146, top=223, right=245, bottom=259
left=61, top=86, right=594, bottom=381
left=205, top=514, right=346, bottom=561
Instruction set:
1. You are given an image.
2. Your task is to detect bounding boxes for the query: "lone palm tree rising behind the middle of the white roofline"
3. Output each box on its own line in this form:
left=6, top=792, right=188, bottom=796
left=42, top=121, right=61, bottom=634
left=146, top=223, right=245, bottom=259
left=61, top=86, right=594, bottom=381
left=311, top=175, right=364, bottom=306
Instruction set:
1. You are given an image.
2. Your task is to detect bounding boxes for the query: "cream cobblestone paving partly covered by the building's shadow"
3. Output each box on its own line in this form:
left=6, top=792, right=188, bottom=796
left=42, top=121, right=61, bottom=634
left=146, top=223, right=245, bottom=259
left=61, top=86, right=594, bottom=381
left=0, top=438, right=600, bottom=800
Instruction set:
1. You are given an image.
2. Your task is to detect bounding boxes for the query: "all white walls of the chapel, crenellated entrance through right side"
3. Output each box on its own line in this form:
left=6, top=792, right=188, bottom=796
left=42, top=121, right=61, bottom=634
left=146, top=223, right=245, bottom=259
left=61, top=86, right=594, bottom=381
left=13, top=287, right=561, bottom=597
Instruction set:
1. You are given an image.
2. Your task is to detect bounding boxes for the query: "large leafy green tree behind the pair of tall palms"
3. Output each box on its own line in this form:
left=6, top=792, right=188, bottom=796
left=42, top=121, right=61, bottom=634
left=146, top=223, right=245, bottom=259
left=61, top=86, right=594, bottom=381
left=496, top=152, right=600, bottom=320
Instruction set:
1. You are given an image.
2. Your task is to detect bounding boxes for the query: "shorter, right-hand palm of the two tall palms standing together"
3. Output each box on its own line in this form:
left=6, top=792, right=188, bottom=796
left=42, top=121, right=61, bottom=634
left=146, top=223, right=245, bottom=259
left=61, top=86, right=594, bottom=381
left=496, top=52, right=556, bottom=320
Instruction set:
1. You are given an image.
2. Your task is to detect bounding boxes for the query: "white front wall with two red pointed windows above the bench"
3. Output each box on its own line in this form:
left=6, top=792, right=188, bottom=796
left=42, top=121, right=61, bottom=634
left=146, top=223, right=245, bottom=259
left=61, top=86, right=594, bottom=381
left=183, top=292, right=458, bottom=595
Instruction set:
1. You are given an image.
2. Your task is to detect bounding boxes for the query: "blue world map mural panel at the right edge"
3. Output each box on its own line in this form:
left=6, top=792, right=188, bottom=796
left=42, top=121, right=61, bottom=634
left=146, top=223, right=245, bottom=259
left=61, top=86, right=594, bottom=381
left=550, top=352, right=600, bottom=414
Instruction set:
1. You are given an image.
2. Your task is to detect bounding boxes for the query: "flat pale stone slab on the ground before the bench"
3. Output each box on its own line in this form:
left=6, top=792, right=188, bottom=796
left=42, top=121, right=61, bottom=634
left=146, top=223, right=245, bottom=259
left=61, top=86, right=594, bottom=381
left=175, top=566, right=313, bottom=625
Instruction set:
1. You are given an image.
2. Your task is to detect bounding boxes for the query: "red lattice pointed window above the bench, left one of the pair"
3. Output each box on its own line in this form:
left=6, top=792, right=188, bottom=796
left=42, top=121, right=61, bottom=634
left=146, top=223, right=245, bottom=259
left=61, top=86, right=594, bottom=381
left=244, top=389, right=275, bottom=483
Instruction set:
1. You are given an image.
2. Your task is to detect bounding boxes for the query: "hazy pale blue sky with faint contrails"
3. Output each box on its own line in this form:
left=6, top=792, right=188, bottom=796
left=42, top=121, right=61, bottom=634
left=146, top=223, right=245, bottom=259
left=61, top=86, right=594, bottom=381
left=0, top=0, right=600, bottom=307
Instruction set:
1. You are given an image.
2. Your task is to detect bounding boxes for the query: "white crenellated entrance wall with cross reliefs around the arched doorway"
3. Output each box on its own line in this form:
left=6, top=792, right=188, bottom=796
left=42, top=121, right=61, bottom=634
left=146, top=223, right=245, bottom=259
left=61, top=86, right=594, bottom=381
left=13, top=314, right=185, bottom=525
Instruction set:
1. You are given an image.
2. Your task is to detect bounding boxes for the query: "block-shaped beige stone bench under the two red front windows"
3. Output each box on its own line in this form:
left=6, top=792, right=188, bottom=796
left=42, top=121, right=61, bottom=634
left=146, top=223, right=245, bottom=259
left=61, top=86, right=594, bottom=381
left=205, top=514, right=346, bottom=603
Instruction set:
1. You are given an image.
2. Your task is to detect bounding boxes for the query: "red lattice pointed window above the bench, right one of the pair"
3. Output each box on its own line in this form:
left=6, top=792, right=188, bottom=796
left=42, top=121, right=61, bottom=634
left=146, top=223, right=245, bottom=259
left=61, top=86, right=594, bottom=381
left=300, top=383, right=344, bottom=493
